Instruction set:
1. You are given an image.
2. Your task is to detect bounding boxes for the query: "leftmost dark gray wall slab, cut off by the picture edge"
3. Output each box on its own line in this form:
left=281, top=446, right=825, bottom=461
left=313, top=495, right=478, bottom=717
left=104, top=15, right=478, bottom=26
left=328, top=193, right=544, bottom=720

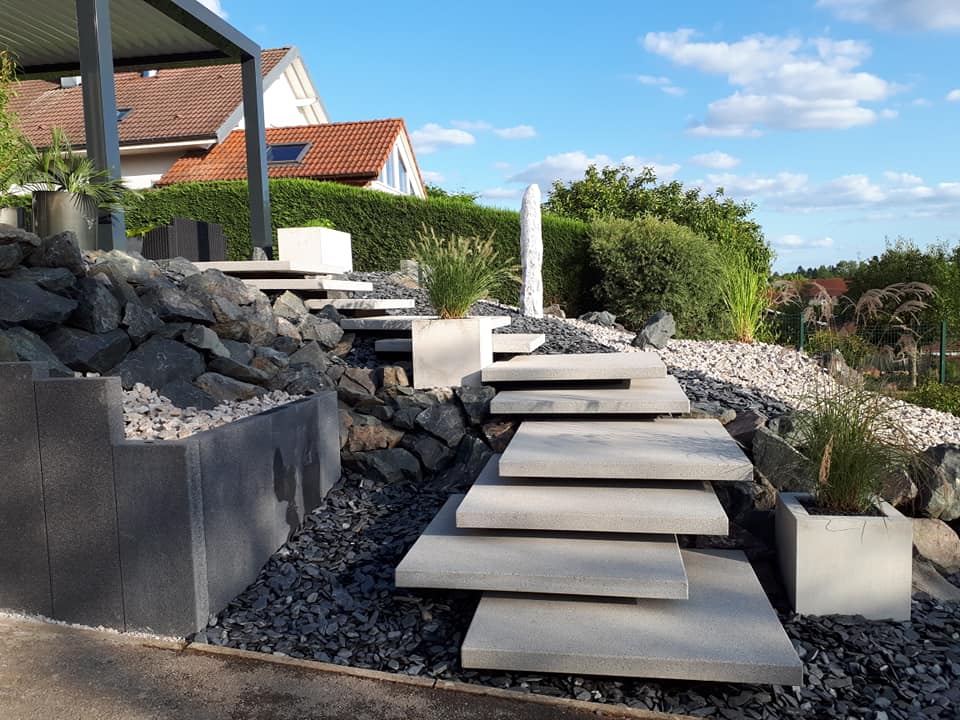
left=0, top=363, right=53, bottom=616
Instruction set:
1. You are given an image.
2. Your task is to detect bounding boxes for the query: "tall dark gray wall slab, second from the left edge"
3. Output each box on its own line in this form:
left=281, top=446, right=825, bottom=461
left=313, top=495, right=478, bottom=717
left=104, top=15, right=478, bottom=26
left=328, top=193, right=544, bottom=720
left=34, top=378, right=124, bottom=628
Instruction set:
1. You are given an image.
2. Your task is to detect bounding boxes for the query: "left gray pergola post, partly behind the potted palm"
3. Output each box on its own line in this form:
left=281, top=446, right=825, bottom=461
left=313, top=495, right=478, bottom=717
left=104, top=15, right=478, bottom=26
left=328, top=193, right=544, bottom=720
left=77, top=0, right=127, bottom=250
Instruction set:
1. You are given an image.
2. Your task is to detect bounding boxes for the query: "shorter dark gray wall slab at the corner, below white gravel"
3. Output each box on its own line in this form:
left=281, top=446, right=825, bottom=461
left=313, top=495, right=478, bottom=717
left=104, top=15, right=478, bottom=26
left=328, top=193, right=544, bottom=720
left=113, top=439, right=210, bottom=637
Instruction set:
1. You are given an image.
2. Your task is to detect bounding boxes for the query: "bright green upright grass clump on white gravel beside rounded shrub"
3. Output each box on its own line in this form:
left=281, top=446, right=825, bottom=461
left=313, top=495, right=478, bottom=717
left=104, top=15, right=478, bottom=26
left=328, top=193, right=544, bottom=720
left=719, top=252, right=768, bottom=343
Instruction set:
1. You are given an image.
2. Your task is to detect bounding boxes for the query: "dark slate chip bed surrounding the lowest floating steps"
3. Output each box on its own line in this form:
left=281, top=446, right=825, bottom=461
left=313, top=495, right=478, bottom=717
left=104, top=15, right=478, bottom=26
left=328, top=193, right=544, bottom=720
left=202, top=476, right=960, bottom=720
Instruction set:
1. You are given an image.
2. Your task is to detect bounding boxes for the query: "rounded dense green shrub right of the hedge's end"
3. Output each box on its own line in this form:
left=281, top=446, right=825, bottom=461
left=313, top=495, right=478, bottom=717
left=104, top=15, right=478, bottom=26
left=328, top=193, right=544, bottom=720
left=590, top=216, right=718, bottom=337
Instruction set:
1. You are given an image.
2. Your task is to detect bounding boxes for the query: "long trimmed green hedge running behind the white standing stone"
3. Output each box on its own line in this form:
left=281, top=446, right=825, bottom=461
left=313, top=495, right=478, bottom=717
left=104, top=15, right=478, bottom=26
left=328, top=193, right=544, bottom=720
left=127, top=180, right=592, bottom=312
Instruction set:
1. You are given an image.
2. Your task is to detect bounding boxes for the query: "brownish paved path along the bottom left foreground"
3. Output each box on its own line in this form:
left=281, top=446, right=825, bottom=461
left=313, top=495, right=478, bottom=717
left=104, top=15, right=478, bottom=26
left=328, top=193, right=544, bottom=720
left=0, top=616, right=688, bottom=720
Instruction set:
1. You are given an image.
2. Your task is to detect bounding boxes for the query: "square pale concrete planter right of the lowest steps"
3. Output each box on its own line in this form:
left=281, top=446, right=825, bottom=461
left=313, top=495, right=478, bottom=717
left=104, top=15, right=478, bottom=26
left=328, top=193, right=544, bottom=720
left=776, top=493, right=913, bottom=621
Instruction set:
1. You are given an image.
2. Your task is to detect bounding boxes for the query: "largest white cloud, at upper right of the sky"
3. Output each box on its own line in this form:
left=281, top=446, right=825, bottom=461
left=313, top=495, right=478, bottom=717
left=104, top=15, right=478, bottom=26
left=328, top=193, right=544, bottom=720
left=643, top=29, right=900, bottom=137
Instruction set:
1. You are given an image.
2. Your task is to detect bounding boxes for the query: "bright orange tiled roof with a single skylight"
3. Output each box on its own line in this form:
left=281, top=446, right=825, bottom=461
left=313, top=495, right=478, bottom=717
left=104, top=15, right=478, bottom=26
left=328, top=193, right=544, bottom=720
left=157, top=118, right=420, bottom=185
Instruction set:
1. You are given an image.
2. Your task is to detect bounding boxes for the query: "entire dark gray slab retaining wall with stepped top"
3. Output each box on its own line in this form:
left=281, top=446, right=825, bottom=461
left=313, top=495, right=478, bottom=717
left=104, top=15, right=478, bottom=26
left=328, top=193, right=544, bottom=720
left=0, top=363, right=340, bottom=636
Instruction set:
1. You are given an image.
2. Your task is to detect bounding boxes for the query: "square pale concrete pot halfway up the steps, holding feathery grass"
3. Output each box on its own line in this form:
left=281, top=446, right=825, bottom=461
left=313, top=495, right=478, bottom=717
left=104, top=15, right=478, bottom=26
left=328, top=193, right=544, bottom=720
left=411, top=317, right=493, bottom=388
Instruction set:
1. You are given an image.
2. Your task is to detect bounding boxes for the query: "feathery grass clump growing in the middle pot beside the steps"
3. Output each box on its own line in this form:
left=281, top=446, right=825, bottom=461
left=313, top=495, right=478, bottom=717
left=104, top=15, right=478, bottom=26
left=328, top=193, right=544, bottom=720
left=411, top=227, right=519, bottom=319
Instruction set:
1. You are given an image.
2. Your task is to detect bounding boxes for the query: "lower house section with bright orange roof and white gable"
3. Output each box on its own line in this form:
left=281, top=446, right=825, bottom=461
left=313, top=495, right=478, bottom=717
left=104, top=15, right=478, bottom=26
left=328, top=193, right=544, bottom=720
left=157, top=118, right=427, bottom=198
